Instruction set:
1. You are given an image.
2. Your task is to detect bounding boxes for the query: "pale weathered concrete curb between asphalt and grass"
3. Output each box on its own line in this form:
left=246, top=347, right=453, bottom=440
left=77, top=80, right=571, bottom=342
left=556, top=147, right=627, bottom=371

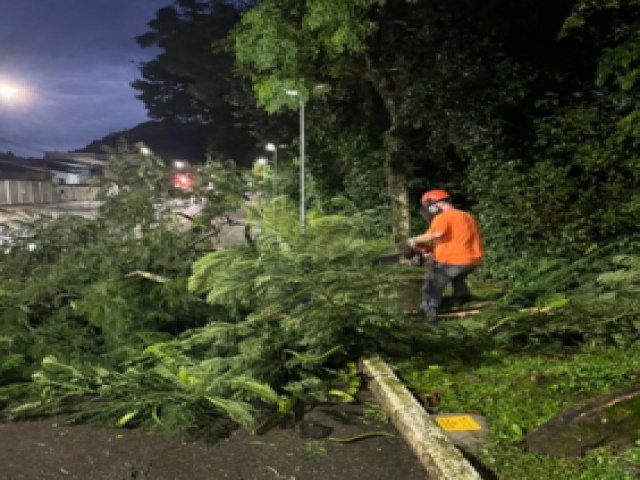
left=361, top=357, right=482, bottom=480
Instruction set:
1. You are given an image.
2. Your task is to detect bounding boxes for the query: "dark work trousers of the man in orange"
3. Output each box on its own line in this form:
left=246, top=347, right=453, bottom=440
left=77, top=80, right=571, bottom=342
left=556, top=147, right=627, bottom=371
left=421, top=262, right=476, bottom=313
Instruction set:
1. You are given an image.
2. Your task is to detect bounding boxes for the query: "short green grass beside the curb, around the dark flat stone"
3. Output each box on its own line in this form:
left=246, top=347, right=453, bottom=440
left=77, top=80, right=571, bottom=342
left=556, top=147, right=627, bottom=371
left=395, top=342, right=640, bottom=480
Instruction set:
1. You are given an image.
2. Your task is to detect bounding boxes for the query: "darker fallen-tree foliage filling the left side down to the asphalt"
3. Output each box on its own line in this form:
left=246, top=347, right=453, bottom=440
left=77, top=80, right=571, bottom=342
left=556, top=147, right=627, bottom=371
left=0, top=144, right=256, bottom=428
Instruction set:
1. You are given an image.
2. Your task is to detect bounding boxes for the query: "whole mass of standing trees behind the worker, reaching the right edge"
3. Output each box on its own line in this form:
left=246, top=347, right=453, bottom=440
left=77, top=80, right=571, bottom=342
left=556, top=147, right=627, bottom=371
left=131, top=0, right=640, bottom=259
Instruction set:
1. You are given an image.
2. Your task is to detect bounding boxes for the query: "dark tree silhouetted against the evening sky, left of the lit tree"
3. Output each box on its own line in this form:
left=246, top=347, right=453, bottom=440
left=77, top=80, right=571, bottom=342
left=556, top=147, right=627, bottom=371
left=133, top=0, right=255, bottom=164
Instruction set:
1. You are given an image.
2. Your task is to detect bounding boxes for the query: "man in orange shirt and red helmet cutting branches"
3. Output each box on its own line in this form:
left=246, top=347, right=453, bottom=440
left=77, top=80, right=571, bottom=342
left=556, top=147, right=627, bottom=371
left=408, top=190, right=483, bottom=322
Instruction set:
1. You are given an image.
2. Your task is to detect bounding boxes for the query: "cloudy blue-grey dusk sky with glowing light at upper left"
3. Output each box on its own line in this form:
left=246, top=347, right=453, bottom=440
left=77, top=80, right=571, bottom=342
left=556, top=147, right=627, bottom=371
left=0, top=0, right=172, bottom=157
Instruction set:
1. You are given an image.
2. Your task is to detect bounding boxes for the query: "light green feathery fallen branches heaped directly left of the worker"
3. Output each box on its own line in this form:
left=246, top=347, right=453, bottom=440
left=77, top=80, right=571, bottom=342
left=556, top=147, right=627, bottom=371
left=189, top=198, right=412, bottom=388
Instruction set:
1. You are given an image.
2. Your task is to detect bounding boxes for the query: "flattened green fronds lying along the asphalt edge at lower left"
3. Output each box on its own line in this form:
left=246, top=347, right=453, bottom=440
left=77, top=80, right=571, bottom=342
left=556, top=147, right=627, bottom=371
left=8, top=352, right=255, bottom=431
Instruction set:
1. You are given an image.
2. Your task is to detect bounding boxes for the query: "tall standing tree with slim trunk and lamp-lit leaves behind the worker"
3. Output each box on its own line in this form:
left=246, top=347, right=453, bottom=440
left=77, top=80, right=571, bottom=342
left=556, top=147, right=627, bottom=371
left=235, top=0, right=571, bottom=240
